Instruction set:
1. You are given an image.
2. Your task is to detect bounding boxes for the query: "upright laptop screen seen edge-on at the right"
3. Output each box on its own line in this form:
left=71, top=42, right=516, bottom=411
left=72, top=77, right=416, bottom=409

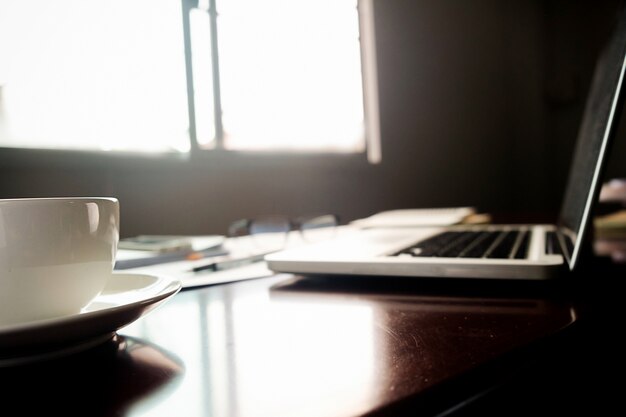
left=558, top=9, right=626, bottom=269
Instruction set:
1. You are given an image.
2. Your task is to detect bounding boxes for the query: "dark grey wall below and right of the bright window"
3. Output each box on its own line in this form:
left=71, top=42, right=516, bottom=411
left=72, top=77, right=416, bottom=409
left=0, top=0, right=626, bottom=236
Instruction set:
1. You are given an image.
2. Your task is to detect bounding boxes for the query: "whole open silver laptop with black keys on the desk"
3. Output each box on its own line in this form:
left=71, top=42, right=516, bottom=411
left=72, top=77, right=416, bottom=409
left=265, top=8, right=626, bottom=280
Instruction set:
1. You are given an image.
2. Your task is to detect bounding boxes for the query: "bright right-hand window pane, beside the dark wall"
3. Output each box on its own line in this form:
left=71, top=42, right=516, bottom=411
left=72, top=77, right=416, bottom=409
left=218, top=0, right=364, bottom=151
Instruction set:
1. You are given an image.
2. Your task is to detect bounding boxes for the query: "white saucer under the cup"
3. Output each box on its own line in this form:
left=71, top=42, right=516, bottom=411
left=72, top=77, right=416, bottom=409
left=0, top=272, right=181, bottom=366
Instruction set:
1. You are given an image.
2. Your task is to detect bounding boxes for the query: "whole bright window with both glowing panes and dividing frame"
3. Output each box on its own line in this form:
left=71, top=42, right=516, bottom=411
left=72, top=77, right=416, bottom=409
left=0, top=0, right=376, bottom=158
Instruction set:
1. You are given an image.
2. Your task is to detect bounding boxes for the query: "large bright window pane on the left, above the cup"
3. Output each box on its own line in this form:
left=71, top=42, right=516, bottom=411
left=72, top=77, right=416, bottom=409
left=0, top=0, right=189, bottom=151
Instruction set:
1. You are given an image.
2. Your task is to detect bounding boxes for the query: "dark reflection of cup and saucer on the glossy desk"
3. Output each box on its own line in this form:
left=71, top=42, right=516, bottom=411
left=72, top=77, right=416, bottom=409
left=0, top=335, right=185, bottom=417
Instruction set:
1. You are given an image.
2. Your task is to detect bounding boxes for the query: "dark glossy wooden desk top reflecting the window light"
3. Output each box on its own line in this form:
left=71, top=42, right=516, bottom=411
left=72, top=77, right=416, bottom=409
left=0, top=255, right=623, bottom=417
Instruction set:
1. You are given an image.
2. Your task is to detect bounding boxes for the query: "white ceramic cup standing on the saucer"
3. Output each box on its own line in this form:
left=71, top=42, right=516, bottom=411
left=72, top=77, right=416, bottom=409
left=0, top=197, right=120, bottom=326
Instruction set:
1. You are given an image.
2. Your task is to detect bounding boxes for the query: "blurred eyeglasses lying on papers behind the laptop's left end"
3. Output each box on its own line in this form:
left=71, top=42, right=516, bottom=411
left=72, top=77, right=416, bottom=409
left=228, top=214, right=339, bottom=252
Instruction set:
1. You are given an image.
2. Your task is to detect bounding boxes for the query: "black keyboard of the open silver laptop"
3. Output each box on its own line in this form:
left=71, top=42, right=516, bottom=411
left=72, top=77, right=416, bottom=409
left=394, top=230, right=530, bottom=259
